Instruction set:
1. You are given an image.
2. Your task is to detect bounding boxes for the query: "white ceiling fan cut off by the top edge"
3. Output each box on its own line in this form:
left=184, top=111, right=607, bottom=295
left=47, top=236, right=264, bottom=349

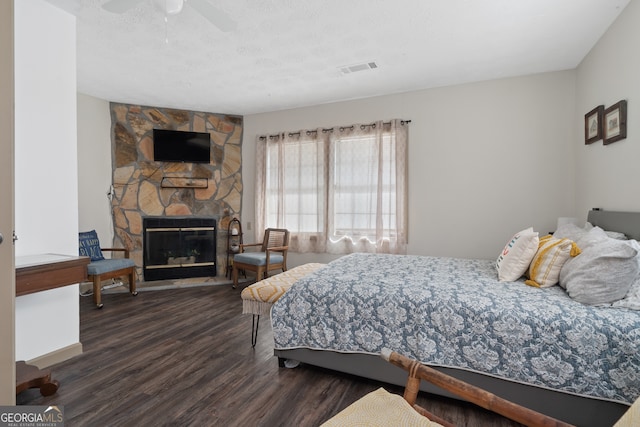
left=102, top=0, right=236, bottom=32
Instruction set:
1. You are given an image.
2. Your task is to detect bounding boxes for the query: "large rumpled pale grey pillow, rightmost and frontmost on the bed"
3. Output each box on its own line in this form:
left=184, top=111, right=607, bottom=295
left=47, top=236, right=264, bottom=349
left=560, top=238, right=640, bottom=305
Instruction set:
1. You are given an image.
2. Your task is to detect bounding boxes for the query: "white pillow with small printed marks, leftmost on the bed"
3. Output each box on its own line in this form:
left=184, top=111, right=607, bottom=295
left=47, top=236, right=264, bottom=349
left=496, top=227, right=539, bottom=282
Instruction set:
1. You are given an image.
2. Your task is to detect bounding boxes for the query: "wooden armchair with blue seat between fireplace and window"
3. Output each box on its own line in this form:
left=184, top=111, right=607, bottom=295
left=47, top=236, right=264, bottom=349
left=232, top=228, right=289, bottom=288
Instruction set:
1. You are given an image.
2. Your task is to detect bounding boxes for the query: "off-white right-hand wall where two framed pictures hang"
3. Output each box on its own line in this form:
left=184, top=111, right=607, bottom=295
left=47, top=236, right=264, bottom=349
left=574, top=0, right=640, bottom=213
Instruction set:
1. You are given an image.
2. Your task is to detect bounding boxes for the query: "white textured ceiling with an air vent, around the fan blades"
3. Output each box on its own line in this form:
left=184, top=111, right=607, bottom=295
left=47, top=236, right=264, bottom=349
left=48, top=0, right=629, bottom=115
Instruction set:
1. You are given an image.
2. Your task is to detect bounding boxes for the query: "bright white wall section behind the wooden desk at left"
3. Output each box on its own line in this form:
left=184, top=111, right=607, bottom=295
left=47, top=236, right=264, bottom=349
left=15, top=0, right=80, bottom=360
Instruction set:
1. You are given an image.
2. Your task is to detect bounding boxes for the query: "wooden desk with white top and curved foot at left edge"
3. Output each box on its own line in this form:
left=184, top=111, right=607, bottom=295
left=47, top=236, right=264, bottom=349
left=16, top=254, right=90, bottom=396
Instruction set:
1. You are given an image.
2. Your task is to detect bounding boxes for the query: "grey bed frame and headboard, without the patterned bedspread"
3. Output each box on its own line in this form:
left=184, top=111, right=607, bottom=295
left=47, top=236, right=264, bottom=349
left=274, top=209, right=640, bottom=427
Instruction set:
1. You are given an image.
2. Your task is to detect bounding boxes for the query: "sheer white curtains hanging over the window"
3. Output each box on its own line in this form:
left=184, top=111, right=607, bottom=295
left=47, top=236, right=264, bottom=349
left=256, top=120, right=408, bottom=254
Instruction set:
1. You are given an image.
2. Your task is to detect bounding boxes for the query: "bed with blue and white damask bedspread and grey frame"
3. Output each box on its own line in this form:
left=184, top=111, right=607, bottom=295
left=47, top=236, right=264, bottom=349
left=271, top=210, right=640, bottom=426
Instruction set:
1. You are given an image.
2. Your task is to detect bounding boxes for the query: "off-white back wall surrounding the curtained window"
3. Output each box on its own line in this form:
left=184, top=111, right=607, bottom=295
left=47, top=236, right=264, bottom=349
left=242, top=71, right=575, bottom=266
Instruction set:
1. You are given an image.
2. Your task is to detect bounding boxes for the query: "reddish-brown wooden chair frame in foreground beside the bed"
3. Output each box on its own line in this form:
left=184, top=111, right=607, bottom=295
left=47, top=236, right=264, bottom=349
left=380, top=348, right=571, bottom=427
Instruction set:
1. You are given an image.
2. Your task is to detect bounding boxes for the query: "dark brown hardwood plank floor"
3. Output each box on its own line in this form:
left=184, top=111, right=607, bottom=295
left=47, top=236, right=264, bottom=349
left=17, top=285, right=518, bottom=427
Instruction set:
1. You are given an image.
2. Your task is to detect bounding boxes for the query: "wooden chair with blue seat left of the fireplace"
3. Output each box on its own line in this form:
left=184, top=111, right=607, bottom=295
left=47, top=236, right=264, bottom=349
left=87, top=248, right=138, bottom=308
